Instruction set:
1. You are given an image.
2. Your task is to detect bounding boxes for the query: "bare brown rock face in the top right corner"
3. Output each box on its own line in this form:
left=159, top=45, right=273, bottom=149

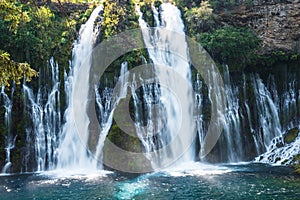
left=215, top=0, right=300, bottom=54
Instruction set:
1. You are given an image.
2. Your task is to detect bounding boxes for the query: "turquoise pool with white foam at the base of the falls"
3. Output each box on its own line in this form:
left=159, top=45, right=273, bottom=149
left=0, top=164, right=300, bottom=200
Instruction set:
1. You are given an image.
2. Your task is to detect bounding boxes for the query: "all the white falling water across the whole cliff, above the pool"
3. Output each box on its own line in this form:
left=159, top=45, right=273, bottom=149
left=1, top=3, right=300, bottom=173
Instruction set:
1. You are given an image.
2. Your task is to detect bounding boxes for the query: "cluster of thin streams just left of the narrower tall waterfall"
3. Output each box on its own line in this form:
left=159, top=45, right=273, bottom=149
left=23, top=58, right=61, bottom=171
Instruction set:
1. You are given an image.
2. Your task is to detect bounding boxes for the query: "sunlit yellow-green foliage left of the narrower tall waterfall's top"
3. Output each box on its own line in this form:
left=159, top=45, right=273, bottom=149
left=0, top=1, right=91, bottom=69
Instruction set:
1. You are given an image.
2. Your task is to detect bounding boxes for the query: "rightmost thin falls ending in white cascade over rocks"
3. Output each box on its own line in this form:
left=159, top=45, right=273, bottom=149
left=255, top=76, right=300, bottom=165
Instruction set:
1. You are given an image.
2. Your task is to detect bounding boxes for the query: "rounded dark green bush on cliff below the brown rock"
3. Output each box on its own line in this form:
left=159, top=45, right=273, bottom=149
left=197, top=26, right=260, bottom=66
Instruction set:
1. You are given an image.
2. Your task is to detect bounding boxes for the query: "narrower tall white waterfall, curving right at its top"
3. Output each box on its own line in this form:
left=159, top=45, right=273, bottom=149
left=57, top=5, right=102, bottom=170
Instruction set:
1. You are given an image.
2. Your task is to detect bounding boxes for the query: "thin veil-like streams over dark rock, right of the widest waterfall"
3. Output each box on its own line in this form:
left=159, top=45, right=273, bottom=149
left=195, top=65, right=297, bottom=162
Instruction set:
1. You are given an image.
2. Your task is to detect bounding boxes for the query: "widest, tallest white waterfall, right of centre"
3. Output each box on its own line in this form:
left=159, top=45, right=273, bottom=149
left=137, top=3, right=195, bottom=169
